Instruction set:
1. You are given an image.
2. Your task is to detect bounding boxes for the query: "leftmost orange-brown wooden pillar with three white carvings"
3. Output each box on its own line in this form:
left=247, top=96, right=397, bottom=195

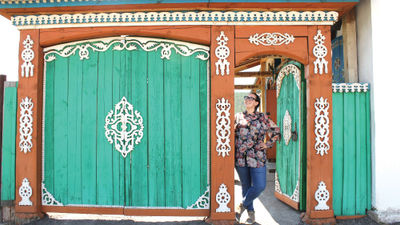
left=15, top=30, right=43, bottom=218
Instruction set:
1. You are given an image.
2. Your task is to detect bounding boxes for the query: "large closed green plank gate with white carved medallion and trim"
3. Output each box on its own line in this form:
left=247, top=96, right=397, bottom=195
left=42, top=37, right=209, bottom=209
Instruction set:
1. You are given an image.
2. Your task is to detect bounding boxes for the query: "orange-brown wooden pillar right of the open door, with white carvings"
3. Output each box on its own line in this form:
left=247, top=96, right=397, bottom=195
left=303, top=26, right=335, bottom=224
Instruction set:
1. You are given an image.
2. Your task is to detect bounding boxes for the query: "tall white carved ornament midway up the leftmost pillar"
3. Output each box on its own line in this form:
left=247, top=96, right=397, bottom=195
left=19, top=97, right=33, bottom=154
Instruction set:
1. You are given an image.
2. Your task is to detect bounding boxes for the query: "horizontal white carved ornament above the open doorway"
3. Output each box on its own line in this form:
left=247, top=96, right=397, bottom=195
left=249, top=33, right=294, bottom=46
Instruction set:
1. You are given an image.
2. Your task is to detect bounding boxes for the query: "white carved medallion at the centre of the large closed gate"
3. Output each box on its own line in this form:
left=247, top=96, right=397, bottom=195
left=104, top=97, right=144, bottom=158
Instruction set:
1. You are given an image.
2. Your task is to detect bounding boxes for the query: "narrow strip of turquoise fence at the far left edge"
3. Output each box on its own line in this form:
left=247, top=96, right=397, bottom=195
left=1, top=83, right=18, bottom=201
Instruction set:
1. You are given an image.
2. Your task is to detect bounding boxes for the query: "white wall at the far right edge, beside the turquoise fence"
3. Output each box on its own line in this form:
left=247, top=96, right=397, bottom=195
left=356, top=0, right=400, bottom=223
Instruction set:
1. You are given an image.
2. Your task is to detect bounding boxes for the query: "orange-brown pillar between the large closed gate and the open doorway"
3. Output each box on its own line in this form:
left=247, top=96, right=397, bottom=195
left=210, top=26, right=235, bottom=224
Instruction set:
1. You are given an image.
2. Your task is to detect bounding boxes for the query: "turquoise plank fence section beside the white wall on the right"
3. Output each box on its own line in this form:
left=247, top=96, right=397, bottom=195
left=332, top=86, right=371, bottom=216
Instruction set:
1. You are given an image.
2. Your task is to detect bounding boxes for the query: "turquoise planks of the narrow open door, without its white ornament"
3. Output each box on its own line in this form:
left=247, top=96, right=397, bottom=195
left=276, top=62, right=306, bottom=209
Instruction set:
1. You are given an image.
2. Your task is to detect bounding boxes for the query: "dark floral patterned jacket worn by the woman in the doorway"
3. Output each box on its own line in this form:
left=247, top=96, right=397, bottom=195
left=235, top=112, right=279, bottom=168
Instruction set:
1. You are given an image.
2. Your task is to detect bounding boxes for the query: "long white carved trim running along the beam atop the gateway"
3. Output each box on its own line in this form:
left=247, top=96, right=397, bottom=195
left=11, top=11, right=339, bottom=29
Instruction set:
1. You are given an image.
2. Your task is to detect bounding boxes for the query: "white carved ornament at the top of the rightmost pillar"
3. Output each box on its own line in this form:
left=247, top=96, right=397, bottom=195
left=313, top=30, right=328, bottom=74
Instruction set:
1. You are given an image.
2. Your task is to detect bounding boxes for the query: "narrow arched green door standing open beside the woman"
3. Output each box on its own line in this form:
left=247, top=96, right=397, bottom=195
left=275, top=62, right=306, bottom=210
